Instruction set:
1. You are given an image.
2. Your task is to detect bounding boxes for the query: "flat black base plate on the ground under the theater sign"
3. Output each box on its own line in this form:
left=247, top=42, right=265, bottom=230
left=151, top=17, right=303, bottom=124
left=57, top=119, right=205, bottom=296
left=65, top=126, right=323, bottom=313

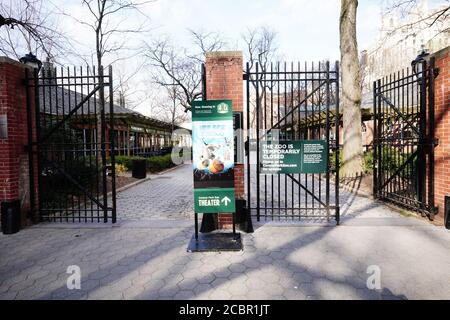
left=187, top=233, right=244, bottom=252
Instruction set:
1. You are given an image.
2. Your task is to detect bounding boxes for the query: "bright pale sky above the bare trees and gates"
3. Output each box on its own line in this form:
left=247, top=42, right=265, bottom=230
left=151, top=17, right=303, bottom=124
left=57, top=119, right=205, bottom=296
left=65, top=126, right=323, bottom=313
left=20, top=0, right=445, bottom=120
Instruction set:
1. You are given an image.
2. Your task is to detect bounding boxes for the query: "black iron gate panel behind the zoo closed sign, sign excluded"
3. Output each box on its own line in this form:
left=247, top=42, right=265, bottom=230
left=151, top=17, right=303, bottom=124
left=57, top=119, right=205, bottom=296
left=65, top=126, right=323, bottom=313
left=244, top=62, right=340, bottom=224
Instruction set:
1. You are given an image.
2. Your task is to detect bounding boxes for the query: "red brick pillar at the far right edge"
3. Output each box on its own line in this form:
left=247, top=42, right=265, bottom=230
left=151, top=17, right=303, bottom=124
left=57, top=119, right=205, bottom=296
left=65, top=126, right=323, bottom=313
left=433, top=47, right=450, bottom=218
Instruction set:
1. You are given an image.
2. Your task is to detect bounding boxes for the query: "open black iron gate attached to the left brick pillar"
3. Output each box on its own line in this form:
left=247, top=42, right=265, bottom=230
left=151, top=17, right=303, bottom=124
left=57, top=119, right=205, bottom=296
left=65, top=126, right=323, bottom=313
left=26, top=64, right=116, bottom=223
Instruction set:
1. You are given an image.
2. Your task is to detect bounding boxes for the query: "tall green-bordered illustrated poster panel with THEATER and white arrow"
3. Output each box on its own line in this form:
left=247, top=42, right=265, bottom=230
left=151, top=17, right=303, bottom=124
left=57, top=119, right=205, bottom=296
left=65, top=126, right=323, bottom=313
left=192, top=100, right=234, bottom=213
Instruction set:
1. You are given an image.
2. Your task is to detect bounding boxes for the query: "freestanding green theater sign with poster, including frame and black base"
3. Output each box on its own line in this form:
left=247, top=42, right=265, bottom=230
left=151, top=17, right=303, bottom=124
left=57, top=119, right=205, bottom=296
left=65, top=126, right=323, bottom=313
left=188, top=100, right=242, bottom=252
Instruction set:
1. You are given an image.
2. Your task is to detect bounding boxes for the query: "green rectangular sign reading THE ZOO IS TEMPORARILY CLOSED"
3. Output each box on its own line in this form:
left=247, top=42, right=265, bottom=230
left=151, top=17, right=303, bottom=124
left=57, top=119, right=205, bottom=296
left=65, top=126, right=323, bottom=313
left=260, top=140, right=328, bottom=174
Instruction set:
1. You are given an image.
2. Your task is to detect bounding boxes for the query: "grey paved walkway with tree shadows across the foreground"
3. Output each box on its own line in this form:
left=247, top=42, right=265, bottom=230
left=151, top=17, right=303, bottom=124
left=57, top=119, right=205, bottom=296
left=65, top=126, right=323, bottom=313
left=0, top=166, right=450, bottom=299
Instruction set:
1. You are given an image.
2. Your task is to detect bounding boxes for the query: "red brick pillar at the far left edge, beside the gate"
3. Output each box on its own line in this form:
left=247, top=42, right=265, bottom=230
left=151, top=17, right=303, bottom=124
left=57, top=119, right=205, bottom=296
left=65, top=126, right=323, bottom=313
left=0, top=57, right=37, bottom=226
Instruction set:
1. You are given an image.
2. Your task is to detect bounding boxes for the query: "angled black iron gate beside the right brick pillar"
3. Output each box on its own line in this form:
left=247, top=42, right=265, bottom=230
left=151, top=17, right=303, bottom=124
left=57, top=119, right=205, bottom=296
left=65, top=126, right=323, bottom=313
left=373, top=58, right=435, bottom=219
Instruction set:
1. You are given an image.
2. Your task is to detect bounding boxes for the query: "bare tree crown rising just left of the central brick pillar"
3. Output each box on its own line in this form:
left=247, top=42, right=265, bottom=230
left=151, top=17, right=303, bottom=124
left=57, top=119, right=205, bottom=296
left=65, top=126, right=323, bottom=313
left=144, top=30, right=225, bottom=112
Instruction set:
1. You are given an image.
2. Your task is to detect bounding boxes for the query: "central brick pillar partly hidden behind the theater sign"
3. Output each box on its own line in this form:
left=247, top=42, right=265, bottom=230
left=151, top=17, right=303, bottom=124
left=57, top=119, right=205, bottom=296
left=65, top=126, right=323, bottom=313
left=205, top=51, right=245, bottom=228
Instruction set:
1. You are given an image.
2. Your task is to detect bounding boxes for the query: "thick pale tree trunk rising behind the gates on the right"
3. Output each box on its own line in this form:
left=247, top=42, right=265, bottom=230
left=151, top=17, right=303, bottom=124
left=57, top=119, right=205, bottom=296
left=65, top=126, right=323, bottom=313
left=339, top=0, right=363, bottom=177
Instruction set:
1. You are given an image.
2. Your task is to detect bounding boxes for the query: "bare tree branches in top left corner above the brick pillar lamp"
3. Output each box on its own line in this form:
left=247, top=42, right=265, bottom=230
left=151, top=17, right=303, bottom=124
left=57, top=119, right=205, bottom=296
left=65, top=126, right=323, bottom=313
left=0, top=0, right=70, bottom=58
